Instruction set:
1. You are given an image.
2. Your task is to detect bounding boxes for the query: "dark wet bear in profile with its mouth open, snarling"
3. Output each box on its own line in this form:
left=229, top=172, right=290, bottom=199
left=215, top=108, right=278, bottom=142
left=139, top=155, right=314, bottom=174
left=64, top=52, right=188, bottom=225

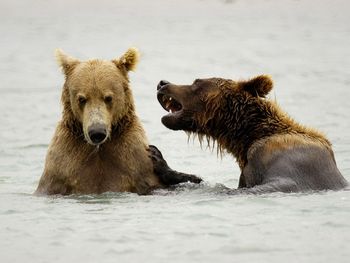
left=152, top=75, right=348, bottom=193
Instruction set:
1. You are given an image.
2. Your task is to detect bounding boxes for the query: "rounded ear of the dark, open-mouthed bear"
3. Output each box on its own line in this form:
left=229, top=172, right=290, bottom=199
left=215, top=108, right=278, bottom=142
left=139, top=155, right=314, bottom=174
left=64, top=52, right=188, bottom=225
left=242, top=75, right=273, bottom=97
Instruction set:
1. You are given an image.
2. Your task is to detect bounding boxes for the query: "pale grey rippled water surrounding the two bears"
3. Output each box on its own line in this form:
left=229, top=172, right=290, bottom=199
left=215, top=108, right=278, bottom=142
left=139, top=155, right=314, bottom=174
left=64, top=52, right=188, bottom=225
left=0, top=0, right=350, bottom=262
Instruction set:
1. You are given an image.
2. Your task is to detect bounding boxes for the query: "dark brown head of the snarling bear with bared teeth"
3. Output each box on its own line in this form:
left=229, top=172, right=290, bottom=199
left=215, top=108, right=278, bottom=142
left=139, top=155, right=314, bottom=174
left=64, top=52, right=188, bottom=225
left=157, top=75, right=273, bottom=135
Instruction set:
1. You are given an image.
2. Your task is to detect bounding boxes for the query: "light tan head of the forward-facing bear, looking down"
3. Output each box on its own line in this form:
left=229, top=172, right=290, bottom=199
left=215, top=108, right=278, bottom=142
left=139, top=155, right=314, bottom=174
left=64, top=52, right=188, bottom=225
left=55, top=48, right=139, bottom=145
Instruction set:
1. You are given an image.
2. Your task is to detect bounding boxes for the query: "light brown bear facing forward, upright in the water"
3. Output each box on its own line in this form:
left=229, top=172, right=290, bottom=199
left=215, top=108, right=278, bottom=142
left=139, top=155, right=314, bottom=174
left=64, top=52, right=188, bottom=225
left=36, top=48, right=200, bottom=195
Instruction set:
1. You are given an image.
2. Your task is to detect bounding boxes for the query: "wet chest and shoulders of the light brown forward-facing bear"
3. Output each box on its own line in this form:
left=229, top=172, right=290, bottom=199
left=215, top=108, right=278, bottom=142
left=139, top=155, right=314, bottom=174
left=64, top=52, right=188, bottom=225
left=37, top=114, right=161, bottom=194
